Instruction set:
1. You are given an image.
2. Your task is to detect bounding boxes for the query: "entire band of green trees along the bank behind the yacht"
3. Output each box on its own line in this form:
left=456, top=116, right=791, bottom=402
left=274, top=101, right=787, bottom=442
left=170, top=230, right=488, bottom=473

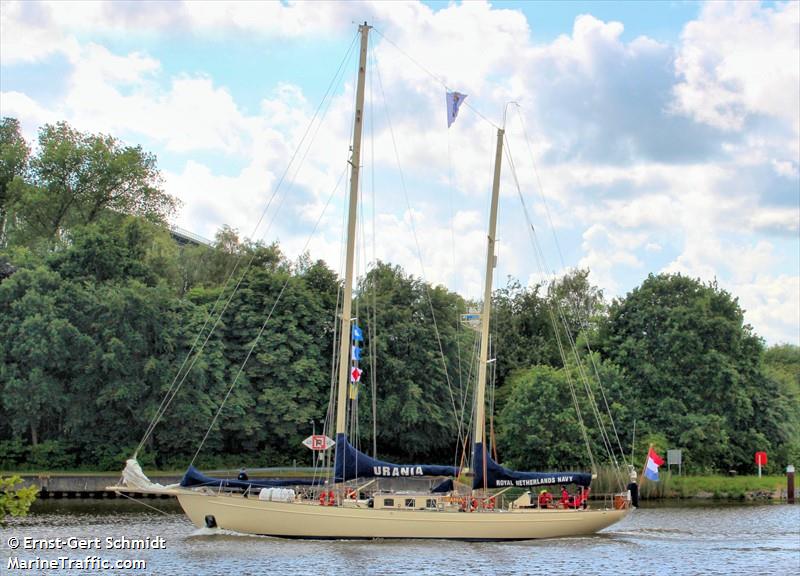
left=0, top=118, right=800, bottom=480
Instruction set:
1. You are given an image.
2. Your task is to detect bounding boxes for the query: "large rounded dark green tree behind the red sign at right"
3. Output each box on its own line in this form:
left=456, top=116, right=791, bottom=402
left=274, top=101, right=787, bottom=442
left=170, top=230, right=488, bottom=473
left=600, top=274, right=785, bottom=471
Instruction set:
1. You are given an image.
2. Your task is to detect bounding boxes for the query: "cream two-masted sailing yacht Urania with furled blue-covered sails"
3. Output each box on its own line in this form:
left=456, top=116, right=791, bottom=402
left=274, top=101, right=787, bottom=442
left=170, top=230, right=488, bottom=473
left=110, top=23, right=635, bottom=540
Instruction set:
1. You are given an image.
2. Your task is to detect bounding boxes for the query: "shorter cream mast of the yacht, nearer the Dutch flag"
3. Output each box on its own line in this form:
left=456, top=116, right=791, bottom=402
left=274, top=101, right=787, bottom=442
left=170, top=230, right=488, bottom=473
left=474, top=128, right=505, bottom=460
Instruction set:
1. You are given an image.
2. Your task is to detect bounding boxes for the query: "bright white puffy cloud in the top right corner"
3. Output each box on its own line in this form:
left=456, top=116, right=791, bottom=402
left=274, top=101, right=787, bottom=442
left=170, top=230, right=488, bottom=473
left=675, top=2, right=800, bottom=143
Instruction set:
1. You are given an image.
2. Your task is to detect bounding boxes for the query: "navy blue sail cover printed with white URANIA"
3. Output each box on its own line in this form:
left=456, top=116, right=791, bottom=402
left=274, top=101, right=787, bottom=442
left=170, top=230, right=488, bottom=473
left=334, top=434, right=458, bottom=482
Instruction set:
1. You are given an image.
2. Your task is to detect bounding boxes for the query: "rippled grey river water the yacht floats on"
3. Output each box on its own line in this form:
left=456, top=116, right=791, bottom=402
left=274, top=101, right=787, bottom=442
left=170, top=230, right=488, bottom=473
left=0, top=500, right=800, bottom=576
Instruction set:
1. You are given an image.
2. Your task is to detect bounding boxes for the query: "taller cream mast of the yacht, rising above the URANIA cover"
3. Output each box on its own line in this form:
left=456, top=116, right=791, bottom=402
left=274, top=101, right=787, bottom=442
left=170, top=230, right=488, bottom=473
left=336, top=22, right=371, bottom=437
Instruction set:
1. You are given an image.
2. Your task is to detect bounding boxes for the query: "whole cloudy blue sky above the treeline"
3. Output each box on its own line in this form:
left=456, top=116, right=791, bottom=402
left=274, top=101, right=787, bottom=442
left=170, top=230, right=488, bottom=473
left=0, top=1, right=800, bottom=344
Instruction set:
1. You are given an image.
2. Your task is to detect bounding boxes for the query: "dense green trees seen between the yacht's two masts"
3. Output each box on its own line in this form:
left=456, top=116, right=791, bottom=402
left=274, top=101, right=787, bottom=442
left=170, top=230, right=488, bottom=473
left=356, top=262, right=474, bottom=462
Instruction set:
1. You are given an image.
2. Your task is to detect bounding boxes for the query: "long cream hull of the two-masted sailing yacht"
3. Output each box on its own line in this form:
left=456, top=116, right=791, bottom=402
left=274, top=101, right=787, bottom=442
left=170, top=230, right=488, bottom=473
left=175, top=490, right=628, bottom=540
